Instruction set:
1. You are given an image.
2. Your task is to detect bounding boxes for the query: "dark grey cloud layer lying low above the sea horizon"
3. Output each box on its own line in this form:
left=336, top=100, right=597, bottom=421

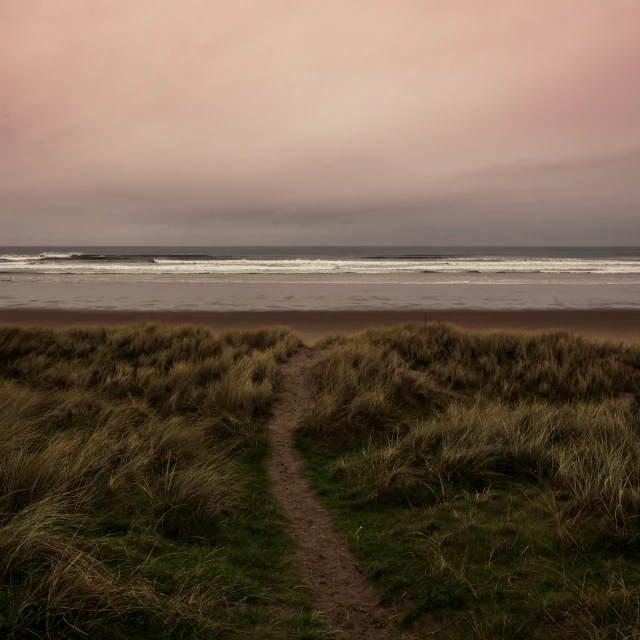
left=0, top=154, right=640, bottom=245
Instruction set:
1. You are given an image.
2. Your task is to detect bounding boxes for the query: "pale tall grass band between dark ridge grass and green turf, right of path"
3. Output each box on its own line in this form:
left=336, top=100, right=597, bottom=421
left=337, top=402, right=640, bottom=541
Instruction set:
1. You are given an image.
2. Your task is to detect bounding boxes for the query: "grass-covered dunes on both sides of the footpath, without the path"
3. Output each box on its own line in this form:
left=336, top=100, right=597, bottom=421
left=5, top=323, right=640, bottom=640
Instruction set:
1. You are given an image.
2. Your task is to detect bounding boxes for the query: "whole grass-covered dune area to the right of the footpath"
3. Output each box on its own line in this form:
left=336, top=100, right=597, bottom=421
left=299, top=324, right=640, bottom=638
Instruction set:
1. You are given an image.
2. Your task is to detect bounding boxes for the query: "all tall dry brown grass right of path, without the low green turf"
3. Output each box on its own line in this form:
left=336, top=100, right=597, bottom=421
left=304, top=323, right=640, bottom=538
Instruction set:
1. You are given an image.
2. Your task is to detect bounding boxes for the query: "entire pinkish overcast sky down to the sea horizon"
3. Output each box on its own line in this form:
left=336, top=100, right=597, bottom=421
left=0, top=0, right=640, bottom=246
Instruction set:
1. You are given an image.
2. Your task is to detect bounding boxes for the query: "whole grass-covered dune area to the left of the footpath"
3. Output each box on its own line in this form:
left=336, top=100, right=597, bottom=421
left=0, top=325, right=325, bottom=639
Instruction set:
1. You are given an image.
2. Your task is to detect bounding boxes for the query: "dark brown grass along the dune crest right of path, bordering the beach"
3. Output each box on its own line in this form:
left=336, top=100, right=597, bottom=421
left=359, top=323, right=640, bottom=401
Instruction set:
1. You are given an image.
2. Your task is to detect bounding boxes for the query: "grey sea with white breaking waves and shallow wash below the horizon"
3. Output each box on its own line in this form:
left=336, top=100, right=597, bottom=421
left=0, top=247, right=640, bottom=311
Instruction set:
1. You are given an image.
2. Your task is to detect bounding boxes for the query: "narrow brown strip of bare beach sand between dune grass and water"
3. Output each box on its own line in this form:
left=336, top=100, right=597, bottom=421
left=0, top=308, right=640, bottom=342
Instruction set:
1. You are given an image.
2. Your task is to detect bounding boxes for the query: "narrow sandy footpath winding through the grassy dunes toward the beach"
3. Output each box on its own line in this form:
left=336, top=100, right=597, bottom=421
left=268, top=348, right=416, bottom=640
